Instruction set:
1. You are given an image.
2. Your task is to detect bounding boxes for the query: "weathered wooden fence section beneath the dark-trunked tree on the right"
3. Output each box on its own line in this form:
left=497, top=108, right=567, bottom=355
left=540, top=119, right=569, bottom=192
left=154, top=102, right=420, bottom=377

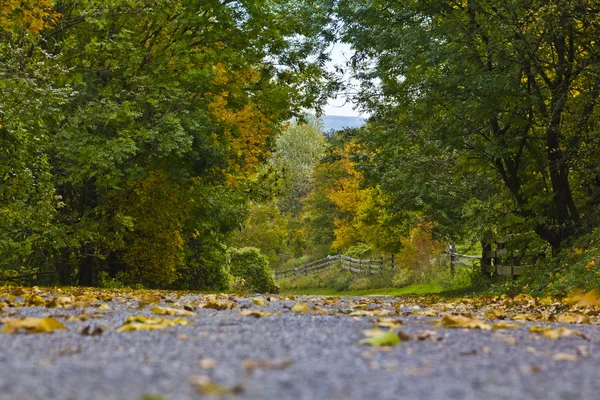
left=448, top=236, right=545, bottom=276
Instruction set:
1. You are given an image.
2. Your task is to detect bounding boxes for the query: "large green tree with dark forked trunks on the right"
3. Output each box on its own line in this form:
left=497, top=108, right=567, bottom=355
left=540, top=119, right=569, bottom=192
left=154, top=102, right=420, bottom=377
left=339, top=0, right=600, bottom=250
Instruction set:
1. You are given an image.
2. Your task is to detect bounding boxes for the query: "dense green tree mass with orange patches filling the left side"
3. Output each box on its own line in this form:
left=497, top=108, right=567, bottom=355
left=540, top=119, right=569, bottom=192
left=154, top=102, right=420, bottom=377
left=0, top=0, right=338, bottom=287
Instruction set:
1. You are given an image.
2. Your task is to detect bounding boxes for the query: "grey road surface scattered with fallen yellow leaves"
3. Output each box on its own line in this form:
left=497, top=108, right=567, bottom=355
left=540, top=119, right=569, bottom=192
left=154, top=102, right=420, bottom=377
left=0, top=295, right=600, bottom=400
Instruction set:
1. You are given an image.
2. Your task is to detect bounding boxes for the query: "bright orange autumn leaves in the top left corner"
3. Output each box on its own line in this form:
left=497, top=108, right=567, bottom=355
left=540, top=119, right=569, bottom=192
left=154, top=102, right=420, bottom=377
left=0, top=0, right=60, bottom=34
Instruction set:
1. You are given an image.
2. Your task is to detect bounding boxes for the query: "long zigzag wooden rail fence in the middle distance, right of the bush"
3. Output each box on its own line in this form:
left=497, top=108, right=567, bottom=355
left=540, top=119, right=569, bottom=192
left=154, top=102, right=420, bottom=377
left=274, top=254, right=394, bottom=278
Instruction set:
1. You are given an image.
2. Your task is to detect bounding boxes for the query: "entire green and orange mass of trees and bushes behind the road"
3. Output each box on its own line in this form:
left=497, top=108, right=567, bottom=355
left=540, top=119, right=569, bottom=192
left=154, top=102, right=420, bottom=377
left=0, top=0, right=600, bottom=296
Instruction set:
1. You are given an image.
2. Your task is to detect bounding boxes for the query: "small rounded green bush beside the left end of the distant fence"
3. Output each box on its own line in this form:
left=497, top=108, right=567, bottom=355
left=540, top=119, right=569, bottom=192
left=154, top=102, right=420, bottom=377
left=228, top=247, right=279, bottom=293
